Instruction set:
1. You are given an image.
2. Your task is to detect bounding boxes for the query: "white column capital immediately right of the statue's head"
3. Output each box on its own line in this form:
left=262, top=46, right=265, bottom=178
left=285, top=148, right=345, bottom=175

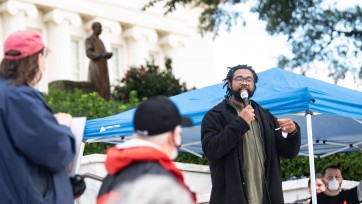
left=124, top=26, right=158, bottom=43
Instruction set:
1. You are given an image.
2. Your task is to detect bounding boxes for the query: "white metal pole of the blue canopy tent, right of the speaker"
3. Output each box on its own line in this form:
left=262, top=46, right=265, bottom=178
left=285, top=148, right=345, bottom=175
left=305, top=111, right=317, bottom=204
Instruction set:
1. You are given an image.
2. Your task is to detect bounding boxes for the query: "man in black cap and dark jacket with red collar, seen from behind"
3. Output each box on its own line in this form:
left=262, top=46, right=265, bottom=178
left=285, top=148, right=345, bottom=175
left=97, top=96, right=196, bottom=204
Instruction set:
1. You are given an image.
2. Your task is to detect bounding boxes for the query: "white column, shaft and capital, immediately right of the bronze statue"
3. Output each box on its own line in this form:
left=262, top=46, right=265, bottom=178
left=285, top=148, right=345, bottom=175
left=124, top=27, right=158, bottom=66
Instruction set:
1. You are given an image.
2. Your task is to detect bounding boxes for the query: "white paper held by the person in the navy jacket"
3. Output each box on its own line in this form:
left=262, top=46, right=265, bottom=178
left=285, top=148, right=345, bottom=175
left=67, top=117, right=87, bottom=176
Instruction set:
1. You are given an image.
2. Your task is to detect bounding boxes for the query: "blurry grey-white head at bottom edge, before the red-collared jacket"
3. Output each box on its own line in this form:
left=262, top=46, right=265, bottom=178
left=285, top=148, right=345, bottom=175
left=107, top=174, right=194, bottom=204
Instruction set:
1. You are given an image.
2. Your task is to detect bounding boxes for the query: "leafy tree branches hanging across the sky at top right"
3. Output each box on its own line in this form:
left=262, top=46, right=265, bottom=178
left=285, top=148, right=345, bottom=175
left=144, top=0, right=362, bottom=82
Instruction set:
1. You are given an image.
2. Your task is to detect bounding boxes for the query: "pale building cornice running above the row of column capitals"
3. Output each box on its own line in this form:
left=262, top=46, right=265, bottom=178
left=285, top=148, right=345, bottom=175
left=12, top=0, right=197, bottom=36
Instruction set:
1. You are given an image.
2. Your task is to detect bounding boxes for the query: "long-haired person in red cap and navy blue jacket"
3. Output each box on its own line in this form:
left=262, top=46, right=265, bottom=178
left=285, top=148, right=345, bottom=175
left=0, top=31, right=74, bottom=204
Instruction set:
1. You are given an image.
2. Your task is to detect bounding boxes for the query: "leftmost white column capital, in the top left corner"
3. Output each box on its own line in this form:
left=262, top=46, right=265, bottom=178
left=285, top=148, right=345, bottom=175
left=0, top=1, right=38, bottom=18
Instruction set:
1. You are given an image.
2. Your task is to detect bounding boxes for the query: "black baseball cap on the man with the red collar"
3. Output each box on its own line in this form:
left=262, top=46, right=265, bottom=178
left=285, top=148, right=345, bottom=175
left=133, top=96, right=192, bottom=136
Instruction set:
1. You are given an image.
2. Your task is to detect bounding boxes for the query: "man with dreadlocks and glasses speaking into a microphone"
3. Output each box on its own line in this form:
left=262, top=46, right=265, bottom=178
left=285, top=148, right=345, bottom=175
left=201, top=65, right=301, bottom=204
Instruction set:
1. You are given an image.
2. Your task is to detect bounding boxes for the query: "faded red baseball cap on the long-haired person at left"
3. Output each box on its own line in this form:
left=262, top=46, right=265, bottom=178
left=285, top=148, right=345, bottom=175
left=4, top=30, right=50, bottom=60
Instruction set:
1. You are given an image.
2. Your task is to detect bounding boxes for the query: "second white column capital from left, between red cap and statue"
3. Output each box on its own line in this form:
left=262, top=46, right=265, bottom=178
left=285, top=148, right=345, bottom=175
left=43, top=9, right=82, bottom=27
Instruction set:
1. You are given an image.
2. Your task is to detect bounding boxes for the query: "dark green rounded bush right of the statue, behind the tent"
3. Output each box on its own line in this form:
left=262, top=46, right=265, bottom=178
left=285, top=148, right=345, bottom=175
left=113, top=58, right=192, bottom=102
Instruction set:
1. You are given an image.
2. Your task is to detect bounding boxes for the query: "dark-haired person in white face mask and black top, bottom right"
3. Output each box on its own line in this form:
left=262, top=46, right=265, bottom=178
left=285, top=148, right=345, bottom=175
left=317, top=165, right=362, bottom=204
